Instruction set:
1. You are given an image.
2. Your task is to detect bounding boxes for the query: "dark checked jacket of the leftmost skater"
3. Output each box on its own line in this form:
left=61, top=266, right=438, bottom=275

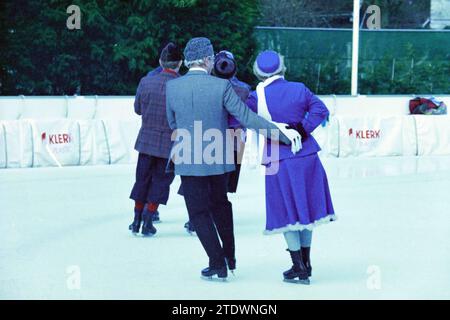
left=134, top=70, right=178, bottom=159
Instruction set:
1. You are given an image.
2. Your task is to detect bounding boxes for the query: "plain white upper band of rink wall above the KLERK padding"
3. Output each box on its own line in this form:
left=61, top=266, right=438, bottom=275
left=0, top=94, right=450, bottom=121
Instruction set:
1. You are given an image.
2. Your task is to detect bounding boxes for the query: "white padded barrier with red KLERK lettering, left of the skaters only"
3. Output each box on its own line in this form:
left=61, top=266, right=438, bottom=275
left=0, top=119, right=140, bottom=168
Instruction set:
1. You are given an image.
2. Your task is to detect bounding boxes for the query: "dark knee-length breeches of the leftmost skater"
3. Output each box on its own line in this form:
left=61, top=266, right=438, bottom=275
left=130, top=153, right=175, bottom=204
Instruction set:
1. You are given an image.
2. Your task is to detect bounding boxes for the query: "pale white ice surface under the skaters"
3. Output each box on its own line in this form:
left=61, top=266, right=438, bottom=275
left=0, top=157, right=450, bottom=299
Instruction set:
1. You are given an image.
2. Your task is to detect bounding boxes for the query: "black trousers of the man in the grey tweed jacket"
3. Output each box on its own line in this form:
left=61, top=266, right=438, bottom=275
left=181, top=174, right=235, bottom=268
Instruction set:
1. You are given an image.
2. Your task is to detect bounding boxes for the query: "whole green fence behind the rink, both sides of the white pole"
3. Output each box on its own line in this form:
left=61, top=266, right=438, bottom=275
left=255, top=27, right=450, bottom=94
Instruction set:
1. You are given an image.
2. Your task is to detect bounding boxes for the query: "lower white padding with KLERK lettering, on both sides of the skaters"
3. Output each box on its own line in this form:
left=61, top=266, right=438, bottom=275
left=0, top=115, right=450, bottom=168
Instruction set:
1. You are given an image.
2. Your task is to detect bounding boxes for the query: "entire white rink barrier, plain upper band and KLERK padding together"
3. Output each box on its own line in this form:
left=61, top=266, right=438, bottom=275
left=0, top=95, right=450, bottom=168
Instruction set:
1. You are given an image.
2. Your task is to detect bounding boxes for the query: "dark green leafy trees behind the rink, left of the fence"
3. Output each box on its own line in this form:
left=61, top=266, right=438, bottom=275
left=0, top=0, right=257, bottom=95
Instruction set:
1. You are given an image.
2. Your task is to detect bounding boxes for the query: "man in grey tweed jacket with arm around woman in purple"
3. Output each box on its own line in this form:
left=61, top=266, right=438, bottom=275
left=166, top=38, right=300, bottom=279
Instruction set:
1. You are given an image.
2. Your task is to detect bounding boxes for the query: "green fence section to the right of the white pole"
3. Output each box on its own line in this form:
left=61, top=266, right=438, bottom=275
left=359, top=30, right=450, bottom=94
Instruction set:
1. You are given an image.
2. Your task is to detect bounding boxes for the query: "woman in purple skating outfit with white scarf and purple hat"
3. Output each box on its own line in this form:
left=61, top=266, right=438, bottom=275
left=247, top=51, right=336, bottom=284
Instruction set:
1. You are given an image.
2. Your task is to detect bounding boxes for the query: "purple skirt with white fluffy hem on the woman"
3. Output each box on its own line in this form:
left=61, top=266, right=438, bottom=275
left=264, top=153, right=336, bottom=234
